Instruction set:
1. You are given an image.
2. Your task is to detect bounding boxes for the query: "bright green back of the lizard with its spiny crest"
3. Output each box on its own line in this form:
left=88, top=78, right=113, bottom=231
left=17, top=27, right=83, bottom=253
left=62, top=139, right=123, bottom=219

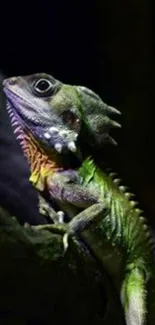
left=79, top=157, right=153, bottom=267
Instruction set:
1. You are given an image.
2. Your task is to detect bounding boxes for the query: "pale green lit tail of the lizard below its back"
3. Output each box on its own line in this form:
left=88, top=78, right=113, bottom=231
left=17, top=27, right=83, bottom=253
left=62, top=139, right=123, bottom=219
left=121, top=266, right=146, bottom=325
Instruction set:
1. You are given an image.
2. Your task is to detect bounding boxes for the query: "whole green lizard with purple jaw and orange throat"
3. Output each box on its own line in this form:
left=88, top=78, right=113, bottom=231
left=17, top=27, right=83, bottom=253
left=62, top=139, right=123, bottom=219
left=4, top=74, right=151, bottom=325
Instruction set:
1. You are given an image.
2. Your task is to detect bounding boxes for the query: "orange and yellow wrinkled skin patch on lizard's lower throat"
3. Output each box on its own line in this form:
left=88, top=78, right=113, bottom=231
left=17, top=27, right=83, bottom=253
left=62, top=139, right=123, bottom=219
left=21, top=131, right=63, bottom=191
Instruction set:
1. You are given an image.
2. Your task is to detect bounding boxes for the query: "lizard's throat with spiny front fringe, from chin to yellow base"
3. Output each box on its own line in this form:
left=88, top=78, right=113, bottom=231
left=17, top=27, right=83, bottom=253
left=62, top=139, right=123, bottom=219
left=6, top=103, right=63, bottom=191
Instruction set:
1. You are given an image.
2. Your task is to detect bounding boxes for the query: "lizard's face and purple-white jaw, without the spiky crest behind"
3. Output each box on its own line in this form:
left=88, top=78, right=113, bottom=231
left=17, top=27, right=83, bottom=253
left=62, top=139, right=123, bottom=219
left=3, top=73, right=80, bottom=153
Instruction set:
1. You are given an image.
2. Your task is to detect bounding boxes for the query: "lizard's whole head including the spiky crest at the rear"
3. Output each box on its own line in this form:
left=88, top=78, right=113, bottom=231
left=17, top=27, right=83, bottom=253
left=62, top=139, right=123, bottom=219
left=3, top=73, right=120, bottom=153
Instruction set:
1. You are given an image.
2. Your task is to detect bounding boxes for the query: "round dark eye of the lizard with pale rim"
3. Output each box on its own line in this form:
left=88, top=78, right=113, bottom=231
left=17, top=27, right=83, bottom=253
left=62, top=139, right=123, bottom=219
left=33, top=78, right=54, bottom=96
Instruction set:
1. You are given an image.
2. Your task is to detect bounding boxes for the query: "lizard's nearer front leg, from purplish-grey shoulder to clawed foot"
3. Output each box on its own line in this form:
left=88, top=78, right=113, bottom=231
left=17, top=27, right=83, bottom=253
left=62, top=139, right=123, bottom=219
left=39, top=173, right=109, bottom=250
